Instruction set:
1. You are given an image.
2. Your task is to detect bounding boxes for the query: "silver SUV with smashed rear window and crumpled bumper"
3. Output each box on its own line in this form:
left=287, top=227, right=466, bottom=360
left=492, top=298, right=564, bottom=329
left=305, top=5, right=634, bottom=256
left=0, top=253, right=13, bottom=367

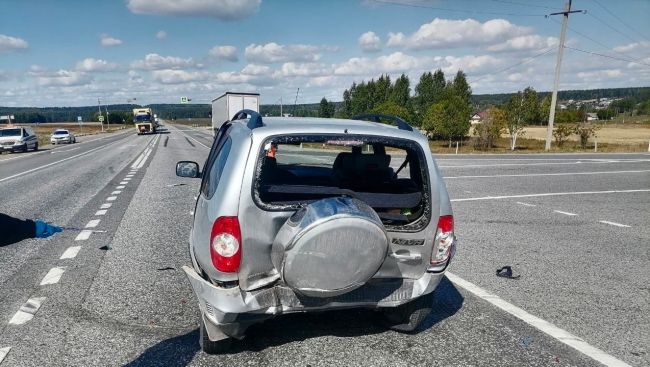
left=176, top=110, right=456, bottom=353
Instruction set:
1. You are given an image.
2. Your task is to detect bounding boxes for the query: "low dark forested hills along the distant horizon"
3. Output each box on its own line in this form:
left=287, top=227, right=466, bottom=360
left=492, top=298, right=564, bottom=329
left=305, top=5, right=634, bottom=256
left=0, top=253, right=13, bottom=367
left=0, top=87, right=650, bottom=123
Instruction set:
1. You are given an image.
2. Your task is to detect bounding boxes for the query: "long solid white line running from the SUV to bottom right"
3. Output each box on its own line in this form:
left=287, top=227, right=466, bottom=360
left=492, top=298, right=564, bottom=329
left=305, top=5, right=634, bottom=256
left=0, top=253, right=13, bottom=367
left=446, top=272, right=630, bottom=367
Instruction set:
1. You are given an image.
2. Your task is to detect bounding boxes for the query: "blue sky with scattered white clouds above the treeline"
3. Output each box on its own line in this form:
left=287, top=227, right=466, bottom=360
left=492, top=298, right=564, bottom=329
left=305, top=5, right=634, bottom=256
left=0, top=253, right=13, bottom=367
left=0, top=0, right=650, bottom=106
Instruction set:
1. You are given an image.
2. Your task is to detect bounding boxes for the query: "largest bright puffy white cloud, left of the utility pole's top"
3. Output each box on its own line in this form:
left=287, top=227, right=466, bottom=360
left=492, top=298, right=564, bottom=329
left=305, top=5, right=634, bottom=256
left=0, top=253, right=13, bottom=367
left=387, top=18, right=532, bottom=50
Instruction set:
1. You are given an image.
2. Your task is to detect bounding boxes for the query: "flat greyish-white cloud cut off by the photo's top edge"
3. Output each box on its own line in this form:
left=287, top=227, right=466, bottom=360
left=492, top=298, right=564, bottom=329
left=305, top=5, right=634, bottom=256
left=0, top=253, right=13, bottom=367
left=126, top=0, right=262, bottom=20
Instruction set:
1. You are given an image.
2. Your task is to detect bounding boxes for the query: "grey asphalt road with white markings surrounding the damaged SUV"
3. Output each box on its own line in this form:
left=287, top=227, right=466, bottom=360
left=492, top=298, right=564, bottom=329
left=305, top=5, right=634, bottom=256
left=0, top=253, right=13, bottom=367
left=0, top=126, right=650, bottom=367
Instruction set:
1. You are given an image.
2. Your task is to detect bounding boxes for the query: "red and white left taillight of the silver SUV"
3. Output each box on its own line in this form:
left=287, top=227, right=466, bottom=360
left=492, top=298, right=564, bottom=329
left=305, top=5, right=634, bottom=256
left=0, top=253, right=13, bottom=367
left=210, top=217, right=241, bottom=273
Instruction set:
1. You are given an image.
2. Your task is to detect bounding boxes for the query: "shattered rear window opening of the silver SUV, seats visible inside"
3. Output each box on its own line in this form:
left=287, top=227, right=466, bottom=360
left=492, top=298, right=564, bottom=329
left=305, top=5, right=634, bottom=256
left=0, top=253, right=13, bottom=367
left=254, top=134, right=429, bottom=229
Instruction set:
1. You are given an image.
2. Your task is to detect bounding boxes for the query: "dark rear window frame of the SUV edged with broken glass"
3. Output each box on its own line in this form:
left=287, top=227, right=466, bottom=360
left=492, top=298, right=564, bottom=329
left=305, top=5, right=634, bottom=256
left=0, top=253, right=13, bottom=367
left=250, top=133, right=432, bottom=232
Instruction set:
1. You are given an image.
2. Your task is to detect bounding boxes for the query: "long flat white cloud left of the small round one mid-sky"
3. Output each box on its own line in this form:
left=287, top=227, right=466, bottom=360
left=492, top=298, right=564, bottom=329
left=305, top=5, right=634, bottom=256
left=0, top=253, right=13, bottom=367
left=244, top=42, right=337, bottom=64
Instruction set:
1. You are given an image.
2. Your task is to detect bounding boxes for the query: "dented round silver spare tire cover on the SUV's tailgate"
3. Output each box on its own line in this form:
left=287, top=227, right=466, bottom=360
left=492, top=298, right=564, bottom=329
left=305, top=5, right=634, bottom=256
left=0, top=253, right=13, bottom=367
left=272, top=197, right=388, bottom=297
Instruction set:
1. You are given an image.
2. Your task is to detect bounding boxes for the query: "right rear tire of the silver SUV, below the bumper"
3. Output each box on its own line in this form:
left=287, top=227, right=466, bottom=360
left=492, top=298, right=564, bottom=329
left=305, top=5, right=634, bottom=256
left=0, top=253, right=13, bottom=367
left=382, top=292, right=433, bottom=333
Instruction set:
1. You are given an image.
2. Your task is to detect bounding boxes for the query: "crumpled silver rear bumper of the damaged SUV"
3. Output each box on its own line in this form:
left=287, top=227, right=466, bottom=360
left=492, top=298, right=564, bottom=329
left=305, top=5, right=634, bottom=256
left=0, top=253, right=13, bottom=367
left=183, top=266, right=444, bottom=340
